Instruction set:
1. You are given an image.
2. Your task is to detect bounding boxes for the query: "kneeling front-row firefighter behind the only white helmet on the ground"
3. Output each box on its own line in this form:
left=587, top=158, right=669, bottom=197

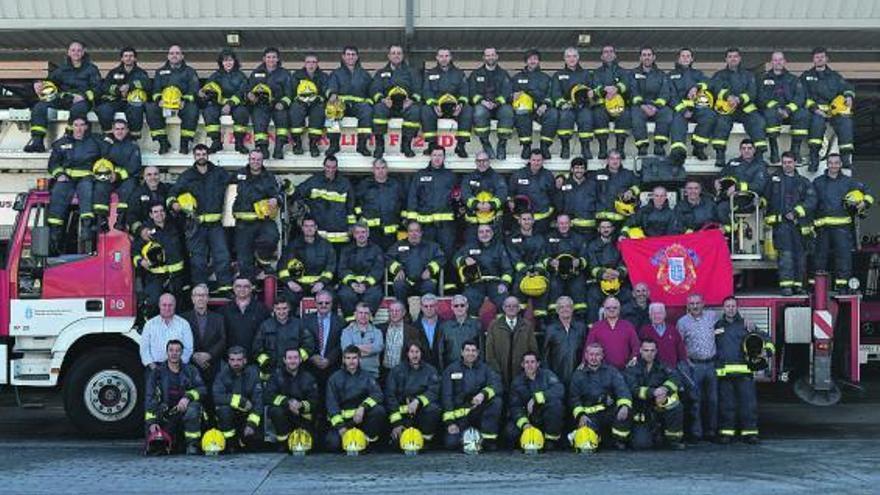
left=440, top=341, right=504, bottom=450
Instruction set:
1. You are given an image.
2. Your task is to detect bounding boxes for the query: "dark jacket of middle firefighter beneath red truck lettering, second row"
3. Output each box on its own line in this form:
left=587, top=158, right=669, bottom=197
left=354, top=177, right=407, bottom=235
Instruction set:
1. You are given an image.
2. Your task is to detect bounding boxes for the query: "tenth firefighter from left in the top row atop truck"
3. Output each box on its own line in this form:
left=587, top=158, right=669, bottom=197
left=468, top=48, right=513, bottom=160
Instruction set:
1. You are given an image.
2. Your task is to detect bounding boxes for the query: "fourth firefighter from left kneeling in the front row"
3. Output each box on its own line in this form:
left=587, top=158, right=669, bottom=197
left=325, top=345, right=386, bottom=452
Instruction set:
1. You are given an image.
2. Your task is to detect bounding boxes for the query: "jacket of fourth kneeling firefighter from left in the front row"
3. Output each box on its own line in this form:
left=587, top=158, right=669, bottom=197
left=326, top=368, right=385, bottom=428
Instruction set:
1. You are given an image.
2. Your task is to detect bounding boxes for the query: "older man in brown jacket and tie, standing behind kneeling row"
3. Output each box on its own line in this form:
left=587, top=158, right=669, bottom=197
left=486, top=296, right=538, bottom=390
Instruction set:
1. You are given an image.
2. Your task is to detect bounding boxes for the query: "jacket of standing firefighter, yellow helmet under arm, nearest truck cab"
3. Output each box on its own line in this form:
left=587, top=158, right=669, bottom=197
left=166, top=162, right=229, bottom=223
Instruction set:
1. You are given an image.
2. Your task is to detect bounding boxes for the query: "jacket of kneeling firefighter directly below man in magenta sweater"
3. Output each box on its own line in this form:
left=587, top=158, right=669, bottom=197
left=568, top=363, right=632, bottom=420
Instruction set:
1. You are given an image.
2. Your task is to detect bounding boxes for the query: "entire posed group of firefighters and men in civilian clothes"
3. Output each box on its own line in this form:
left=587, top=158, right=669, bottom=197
left=26, top=42, right=874, bottom=453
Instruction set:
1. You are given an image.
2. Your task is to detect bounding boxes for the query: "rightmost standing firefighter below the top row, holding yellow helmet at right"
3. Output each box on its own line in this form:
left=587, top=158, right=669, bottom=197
left=813, top=153, right=874, bottom=293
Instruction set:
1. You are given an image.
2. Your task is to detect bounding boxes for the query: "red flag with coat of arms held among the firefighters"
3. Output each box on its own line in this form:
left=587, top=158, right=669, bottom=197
left=619, top=229, right=733, bottom=305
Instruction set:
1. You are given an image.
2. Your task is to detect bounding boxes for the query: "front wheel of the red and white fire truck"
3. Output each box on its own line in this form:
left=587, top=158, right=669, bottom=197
left=64, top=347, right=144, bottom=437
